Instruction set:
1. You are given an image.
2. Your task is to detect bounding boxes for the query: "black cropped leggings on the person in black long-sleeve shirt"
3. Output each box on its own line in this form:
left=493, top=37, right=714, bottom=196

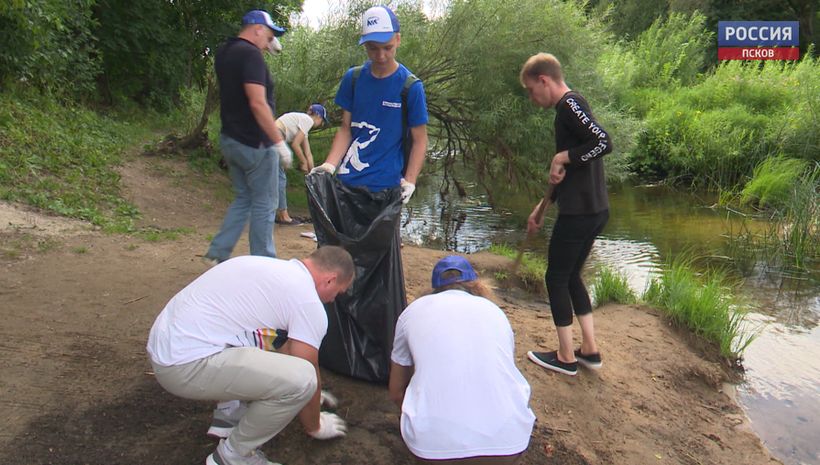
left=544, top=210, right=609, bottom=326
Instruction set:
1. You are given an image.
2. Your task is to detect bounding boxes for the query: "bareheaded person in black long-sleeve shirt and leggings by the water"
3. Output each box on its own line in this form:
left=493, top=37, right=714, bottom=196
left=520, top=53, right=612, bottom=376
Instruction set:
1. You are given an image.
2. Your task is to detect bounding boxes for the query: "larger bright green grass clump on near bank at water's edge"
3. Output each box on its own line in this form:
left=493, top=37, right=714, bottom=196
left=642, top=256, right=754, bottom=361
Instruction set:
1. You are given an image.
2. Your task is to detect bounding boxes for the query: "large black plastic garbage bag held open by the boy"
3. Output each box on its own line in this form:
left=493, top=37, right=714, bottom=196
left=305, top=173, right=407, bottom=383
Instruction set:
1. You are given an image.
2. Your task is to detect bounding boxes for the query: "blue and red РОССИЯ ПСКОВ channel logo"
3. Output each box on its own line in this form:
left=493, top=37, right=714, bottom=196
left=718, top=21, right=800, bottom=60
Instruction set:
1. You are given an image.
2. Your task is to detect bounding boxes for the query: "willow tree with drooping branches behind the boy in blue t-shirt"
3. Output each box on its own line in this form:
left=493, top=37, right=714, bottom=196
left=273, top=0, right=632, bottom=203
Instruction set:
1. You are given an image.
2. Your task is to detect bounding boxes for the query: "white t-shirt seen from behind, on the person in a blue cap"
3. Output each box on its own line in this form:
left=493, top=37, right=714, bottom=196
left=391, top=290, right=535, bottom=459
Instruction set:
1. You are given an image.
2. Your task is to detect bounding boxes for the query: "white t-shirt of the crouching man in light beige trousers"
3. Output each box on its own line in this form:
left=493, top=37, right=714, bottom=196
left=147, top=255, right=327, bottom=366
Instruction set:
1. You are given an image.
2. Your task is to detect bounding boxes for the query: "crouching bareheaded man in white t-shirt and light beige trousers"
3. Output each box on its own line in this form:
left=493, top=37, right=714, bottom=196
left=147, top=246, right=355, bottom=465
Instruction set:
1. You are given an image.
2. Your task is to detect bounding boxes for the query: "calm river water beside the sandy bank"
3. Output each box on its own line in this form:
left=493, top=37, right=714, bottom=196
left=402, top=174, right=820, bottom=465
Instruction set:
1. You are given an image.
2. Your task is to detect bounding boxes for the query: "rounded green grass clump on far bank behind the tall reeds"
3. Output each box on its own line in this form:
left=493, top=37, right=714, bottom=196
left=741, top=156, right=808, bottom=207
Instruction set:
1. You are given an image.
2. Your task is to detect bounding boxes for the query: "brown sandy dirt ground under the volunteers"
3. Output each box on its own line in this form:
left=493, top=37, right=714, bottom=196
left=0, top=154, right=778, bottom=465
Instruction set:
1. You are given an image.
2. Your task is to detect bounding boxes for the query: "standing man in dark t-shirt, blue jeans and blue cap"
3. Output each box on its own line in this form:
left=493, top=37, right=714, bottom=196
left=205, top=10, right=292, bottom=265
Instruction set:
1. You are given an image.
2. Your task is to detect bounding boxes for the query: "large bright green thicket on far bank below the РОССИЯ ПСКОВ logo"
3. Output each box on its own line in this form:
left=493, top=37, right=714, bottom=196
left=630, top=54, right=820, bottom=189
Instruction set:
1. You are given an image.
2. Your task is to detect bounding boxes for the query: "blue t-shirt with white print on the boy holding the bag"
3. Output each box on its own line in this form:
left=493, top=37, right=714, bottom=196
left=335, top=61, right=427, bottom=192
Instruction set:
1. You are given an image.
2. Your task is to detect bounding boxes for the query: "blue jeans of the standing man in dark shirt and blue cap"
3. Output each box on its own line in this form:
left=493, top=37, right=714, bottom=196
left=206, top=134, right=279, bottom=262
